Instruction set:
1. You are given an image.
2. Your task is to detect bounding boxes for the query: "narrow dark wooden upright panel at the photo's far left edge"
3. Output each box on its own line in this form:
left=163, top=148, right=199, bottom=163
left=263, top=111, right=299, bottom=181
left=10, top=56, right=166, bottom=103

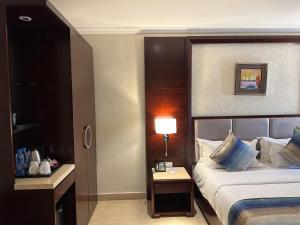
left=0, top=3, right=14, bottom=224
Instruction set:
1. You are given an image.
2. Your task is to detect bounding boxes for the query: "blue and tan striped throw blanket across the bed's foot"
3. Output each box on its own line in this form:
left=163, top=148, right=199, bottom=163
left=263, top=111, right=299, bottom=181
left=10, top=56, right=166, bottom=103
left=228, top=197, right=300, bottom=225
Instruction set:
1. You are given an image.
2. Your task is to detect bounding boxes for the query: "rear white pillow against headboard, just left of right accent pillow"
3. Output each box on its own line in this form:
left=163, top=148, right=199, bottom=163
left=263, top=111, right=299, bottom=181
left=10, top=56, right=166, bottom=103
left=259, top=137, right=291, bottom=163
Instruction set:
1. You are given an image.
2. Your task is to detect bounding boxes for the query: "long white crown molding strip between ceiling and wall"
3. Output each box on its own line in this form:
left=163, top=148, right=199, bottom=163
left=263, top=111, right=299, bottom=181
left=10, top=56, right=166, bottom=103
left=76, top=27, right=300, bottom=35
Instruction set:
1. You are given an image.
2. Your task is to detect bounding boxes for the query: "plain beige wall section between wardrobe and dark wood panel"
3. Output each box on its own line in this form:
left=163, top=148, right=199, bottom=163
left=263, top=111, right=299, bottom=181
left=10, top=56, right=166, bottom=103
left=84, top=35, right=146, bottom=194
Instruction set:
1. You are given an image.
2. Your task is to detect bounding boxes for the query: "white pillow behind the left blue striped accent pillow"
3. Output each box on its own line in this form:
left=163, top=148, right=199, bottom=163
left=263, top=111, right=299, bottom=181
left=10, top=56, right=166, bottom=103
left=196, top=138, right=265, bottom=169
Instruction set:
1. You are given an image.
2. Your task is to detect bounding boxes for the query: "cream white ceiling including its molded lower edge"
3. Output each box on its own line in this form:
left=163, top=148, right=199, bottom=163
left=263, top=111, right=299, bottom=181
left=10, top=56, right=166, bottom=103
left=50, top=0, right=300, bottom=33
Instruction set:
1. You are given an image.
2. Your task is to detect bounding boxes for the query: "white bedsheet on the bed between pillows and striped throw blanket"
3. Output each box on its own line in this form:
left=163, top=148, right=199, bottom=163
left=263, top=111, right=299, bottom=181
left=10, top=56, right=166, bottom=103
left=193, top=163, right=300, bottom=225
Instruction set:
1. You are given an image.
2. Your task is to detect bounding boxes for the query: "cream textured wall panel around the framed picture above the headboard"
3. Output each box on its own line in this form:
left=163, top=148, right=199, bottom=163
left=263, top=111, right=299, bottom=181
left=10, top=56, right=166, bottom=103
left=192, top=43, right=300, bottom=116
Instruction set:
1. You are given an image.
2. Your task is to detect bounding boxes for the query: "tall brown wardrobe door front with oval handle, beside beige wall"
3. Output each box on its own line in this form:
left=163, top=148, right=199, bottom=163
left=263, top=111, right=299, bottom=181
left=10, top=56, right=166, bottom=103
left=71, top=30, right=97, bottom=225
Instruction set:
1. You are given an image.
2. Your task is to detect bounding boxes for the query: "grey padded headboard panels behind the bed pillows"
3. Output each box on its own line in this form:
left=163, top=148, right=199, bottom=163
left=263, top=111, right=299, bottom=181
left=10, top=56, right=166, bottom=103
left=194, top=116, right=300, bottom=140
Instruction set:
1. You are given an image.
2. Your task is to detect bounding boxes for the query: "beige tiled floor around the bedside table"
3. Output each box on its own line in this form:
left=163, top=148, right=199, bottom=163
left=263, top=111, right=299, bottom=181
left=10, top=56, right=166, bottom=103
left=89, top=200, right=207, bottom=225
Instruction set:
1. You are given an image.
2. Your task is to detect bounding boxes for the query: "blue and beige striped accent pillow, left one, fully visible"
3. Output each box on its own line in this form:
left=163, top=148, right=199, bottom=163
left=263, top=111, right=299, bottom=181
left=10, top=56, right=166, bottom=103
left=209, top=133, right=258, bottom=171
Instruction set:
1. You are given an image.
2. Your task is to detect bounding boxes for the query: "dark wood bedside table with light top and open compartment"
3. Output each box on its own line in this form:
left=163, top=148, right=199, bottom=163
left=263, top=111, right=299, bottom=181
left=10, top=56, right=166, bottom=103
left=151, top=167, right=196, bottom=217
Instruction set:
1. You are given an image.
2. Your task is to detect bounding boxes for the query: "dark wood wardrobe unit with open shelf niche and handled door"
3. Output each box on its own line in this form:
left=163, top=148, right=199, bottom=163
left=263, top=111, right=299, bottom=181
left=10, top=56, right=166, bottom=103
left=0, top=0, right=97, bottom=225
